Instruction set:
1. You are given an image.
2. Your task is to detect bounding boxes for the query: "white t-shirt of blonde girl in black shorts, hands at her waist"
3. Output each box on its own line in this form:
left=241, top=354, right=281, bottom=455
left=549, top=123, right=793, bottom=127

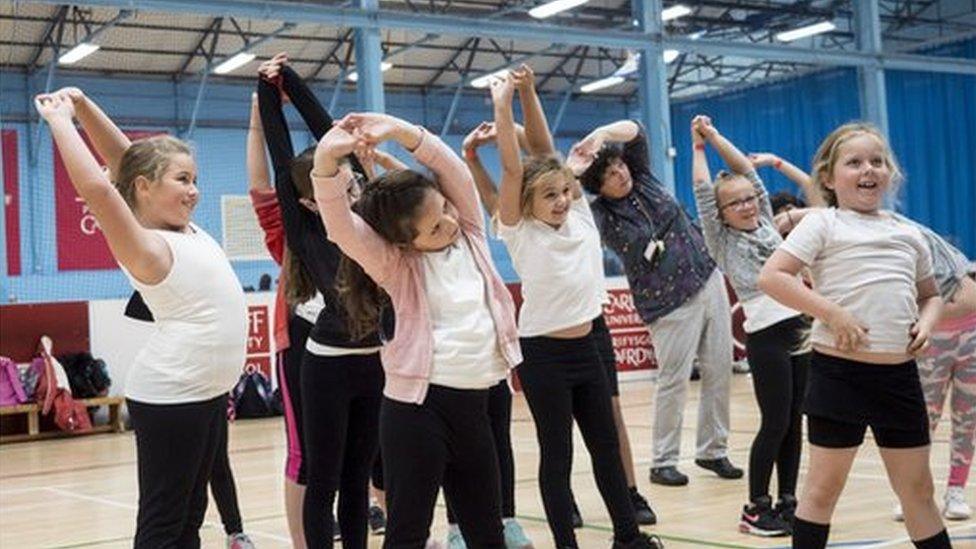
left=781, top=208, right=932, bottom=353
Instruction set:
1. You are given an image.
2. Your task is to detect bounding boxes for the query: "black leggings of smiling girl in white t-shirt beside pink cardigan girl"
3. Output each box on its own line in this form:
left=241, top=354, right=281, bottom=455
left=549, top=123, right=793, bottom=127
left=518, top=335, right=638, bottom=548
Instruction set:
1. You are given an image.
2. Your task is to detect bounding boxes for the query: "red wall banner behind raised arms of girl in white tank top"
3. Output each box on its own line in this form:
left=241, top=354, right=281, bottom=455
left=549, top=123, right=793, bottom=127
left=52, top=131, right=160, bottom=271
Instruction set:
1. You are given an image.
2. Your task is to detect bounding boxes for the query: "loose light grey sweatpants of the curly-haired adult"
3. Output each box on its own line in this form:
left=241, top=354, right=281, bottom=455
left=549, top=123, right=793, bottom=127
left=650, top=269, right=732, bottom=467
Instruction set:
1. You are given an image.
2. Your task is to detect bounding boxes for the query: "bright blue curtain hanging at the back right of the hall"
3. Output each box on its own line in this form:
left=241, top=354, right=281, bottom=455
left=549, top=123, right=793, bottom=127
left=671, top=40, right=976, bottom=255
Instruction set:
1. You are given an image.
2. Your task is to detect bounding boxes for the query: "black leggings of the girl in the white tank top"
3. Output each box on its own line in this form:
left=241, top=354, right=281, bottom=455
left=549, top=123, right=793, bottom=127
left=126, top=394, right=227, bottom=549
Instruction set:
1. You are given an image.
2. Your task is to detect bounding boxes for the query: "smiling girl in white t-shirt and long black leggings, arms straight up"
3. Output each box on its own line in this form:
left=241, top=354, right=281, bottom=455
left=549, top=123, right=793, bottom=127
left=491, top=73, right=657, bottom=548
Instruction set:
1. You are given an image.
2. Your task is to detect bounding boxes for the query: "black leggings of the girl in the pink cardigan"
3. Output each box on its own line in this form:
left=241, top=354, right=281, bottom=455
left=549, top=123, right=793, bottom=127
left=382, top=385, right=505, bottom=549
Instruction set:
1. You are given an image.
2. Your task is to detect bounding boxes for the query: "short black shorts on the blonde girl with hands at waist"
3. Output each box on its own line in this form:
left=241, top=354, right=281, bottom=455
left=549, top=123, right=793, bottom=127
left=804, top=351, right=931, bottom=448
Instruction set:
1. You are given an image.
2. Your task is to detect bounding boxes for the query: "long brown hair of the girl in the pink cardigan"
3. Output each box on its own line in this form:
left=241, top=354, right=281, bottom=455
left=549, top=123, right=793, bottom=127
left=336, top=170, right=440, bottom=339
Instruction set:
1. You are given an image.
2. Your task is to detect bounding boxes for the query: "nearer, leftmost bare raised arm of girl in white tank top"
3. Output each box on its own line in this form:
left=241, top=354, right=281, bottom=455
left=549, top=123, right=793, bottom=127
left=34, top=94, right=173, bottom=284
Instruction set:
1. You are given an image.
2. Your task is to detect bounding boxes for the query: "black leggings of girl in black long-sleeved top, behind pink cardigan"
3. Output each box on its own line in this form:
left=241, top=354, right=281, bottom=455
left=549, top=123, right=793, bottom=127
left=302, top=352, right=383, bottom=549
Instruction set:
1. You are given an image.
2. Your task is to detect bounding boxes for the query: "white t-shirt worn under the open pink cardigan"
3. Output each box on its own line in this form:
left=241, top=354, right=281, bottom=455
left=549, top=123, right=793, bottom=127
left=422, top=236, right=508, bottom=389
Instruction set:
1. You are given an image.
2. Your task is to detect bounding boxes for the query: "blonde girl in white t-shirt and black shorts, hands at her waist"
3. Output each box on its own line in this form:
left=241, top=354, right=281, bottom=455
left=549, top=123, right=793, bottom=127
left=759, top=124, right=951, bottom=549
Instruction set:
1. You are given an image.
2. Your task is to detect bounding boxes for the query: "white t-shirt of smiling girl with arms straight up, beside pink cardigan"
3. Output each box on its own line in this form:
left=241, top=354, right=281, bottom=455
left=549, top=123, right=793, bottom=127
left=495, top=197, right=607, bottom=337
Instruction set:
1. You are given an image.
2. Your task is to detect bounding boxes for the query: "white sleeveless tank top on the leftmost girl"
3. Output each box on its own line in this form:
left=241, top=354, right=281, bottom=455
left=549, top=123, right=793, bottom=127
left=122, top=224, right=247, bottom=404
